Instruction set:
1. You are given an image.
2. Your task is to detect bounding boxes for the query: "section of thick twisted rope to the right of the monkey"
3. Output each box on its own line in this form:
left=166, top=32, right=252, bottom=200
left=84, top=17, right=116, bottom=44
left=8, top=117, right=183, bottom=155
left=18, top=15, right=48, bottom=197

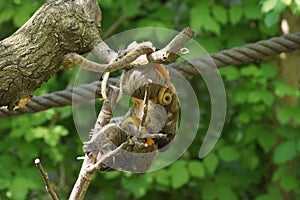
left=169, top=32, right=300, bottom=76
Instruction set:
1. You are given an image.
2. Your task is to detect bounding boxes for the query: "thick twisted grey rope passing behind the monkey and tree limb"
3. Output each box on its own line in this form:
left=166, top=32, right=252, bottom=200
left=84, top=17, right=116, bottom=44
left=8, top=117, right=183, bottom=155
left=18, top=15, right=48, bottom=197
left=0, top=32, right=300, bottom=118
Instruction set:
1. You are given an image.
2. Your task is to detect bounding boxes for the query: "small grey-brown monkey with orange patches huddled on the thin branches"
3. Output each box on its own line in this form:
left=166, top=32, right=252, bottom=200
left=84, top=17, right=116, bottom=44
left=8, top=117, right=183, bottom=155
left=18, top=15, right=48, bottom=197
left=83, top=64, right=180, bottom=173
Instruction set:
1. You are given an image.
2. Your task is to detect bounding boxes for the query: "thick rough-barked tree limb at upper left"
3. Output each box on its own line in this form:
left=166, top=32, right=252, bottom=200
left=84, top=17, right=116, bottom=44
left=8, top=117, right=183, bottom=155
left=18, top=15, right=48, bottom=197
left=0, top=0, right=101, bottom=108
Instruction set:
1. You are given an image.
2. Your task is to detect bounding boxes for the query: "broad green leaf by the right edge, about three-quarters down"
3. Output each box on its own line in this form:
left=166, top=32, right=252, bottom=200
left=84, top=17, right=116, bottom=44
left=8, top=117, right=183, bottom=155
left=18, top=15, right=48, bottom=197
left=274, top=140, right=297, bottom=164
